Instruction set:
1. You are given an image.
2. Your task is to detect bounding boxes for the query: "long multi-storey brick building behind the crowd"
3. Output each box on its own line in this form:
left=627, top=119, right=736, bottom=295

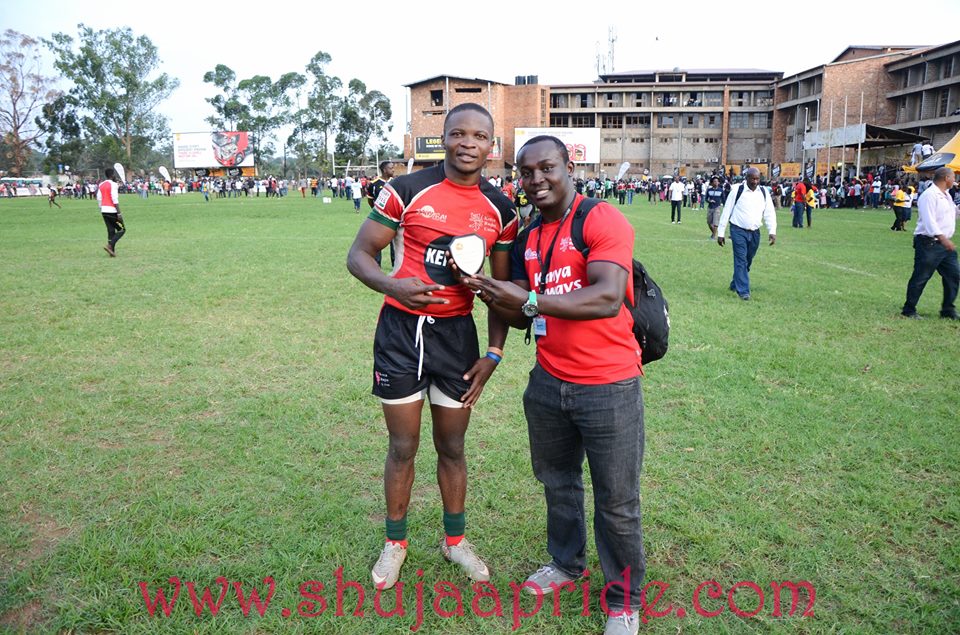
left=404, top=41, right=960, bottom=176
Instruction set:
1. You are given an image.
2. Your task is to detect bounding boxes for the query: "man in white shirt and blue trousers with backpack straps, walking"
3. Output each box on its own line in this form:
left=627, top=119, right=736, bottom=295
left=717, top=168, right=777, bottom=300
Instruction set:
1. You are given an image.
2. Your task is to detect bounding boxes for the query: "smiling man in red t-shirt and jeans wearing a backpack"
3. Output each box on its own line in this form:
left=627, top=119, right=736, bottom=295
left=465, top=136, right=646, bottom=633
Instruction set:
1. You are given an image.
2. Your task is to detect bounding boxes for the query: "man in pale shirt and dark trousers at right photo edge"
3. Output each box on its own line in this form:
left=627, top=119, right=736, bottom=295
left=901, top=167, right=960, bottom=320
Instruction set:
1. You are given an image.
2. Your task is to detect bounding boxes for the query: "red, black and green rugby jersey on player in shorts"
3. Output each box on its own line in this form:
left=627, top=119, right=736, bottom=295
left=369, top=165, right=517, bottom=317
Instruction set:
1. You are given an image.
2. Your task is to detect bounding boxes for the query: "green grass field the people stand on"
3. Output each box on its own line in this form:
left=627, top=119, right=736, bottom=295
left=0, top=195, right=960, bottom=634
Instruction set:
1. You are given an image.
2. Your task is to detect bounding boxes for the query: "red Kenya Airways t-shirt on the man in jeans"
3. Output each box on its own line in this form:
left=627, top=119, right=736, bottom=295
left=511, top=194, right=641, bottom=384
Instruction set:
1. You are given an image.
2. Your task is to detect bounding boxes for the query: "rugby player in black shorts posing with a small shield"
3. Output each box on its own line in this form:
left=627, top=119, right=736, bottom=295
left=347, top=103, right=517, bottom=589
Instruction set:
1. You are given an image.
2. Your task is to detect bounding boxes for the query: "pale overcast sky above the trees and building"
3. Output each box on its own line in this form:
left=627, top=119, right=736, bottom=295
left=7, top=0, right=960, bottom=147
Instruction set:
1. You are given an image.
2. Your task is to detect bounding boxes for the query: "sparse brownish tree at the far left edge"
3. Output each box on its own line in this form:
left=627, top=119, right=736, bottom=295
left=0, top=29, right=60, bottom=175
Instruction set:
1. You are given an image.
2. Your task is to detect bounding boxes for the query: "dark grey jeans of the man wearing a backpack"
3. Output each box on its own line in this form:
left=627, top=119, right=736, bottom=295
left=523, top=364, right=646, bottom=610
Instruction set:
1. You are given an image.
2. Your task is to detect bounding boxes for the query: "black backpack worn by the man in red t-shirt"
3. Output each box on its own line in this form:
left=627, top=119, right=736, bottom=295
left=570, top=198, right=670, bottom=364
